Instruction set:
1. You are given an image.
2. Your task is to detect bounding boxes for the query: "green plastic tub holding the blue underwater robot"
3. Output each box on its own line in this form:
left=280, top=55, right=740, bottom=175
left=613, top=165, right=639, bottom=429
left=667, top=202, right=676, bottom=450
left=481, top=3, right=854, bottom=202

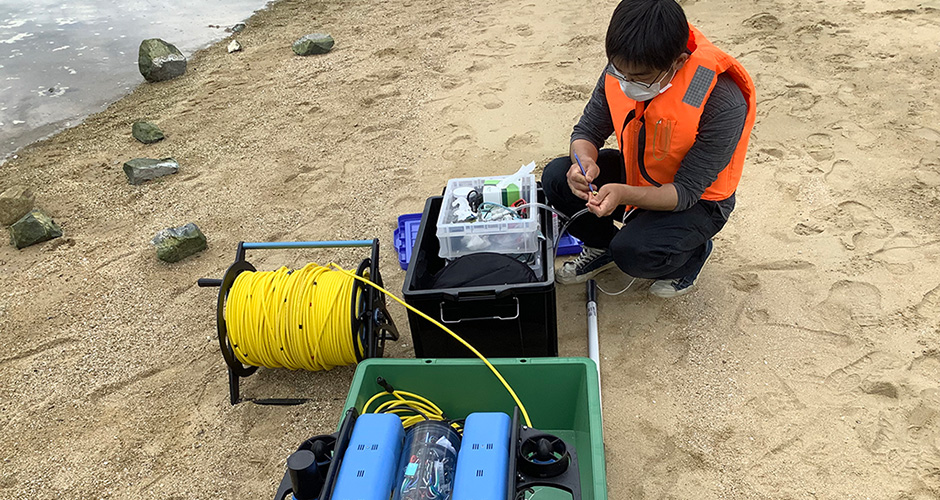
left=343, top=358, right=607, bottom=500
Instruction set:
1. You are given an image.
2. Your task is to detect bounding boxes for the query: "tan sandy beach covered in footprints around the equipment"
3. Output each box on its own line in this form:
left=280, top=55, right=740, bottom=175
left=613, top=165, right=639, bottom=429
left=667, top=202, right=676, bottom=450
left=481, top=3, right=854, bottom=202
left=0, top=0, right=940, bottom=500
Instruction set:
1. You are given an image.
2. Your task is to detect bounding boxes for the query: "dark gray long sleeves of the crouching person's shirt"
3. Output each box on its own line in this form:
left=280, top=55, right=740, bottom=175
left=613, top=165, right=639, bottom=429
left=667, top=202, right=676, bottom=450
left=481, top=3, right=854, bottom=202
left=571, top=71, right=747, bottom=215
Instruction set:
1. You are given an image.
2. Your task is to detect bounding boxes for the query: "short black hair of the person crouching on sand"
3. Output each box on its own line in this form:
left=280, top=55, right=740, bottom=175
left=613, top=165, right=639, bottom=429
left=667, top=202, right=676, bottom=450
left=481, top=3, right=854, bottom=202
left=606, top=0, right=689, bottom=71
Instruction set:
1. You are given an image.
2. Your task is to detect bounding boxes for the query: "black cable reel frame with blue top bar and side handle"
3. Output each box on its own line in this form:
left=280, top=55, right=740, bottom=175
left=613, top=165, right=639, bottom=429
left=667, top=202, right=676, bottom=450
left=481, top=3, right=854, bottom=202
left=197, top=239, right=398, bottom=405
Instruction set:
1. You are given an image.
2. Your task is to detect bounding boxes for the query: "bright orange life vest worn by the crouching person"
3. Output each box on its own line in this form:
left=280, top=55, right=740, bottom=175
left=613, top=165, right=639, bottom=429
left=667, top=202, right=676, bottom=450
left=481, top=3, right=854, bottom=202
left=604, top=24, right=756, bottom=201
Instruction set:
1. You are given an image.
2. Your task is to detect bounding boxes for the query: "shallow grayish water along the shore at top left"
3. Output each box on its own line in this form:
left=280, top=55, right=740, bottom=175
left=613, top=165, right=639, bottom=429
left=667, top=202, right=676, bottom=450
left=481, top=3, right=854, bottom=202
left=0, top=0, right=266, bottom=158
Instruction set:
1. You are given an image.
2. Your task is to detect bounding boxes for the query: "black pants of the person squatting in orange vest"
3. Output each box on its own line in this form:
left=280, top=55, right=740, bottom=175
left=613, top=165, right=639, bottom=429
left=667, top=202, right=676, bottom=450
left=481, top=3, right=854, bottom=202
left=542, top=149, right=727, bottom=279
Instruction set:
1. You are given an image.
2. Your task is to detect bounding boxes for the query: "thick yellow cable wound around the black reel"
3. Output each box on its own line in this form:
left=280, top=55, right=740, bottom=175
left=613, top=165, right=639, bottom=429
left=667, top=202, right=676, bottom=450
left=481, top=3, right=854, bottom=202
left=225, top=263, right=363, bottom=371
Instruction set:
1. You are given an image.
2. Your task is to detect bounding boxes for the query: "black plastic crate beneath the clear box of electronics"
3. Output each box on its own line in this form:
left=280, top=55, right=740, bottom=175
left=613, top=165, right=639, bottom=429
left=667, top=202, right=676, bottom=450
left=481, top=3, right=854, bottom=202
left=402, top=190, right=558, bottom=358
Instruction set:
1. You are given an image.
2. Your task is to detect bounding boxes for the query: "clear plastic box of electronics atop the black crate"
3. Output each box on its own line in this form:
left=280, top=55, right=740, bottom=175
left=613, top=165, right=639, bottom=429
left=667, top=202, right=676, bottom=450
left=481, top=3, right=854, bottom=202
left=437, top=174, right=539, bottom=259
